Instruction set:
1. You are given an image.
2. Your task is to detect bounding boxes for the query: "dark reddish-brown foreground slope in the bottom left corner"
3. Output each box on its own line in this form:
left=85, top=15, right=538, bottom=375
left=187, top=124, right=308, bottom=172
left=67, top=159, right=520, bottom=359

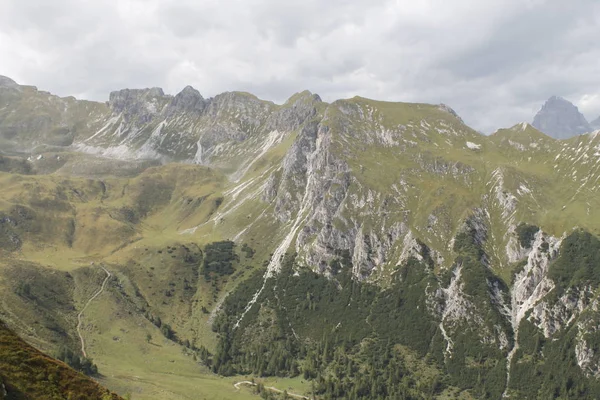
left=0, top=321, right=121, bottom=400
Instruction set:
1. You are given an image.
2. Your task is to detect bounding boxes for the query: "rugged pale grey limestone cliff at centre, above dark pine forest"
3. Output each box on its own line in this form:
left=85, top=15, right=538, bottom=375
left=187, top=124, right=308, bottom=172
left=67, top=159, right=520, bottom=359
left=263, top=102, right=472, bottom=279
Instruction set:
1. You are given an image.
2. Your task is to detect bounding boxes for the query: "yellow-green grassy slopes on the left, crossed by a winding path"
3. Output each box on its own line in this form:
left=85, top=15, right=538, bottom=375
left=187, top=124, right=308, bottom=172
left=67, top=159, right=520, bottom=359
left=0, top=159, right=296, bottom=400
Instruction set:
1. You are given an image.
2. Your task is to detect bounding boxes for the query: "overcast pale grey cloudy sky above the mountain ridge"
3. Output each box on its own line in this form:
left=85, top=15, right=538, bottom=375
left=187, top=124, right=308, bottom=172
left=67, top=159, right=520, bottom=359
left=0, top=0, right=600, bottom=133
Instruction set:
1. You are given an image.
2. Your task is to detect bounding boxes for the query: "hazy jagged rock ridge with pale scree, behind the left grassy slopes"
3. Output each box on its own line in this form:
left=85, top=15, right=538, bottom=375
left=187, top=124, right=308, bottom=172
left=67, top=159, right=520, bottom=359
left=0, top=77, right=328, bottom=170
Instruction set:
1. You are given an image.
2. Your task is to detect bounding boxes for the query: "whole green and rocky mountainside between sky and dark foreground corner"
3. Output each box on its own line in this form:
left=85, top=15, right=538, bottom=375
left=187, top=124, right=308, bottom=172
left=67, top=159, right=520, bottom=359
left=0, top=79, right=600, bottom=399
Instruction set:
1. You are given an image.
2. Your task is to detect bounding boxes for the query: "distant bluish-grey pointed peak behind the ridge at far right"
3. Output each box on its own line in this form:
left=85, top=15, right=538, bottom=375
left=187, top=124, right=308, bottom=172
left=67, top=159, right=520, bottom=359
left=532, top=96, right=592, bottom=139
